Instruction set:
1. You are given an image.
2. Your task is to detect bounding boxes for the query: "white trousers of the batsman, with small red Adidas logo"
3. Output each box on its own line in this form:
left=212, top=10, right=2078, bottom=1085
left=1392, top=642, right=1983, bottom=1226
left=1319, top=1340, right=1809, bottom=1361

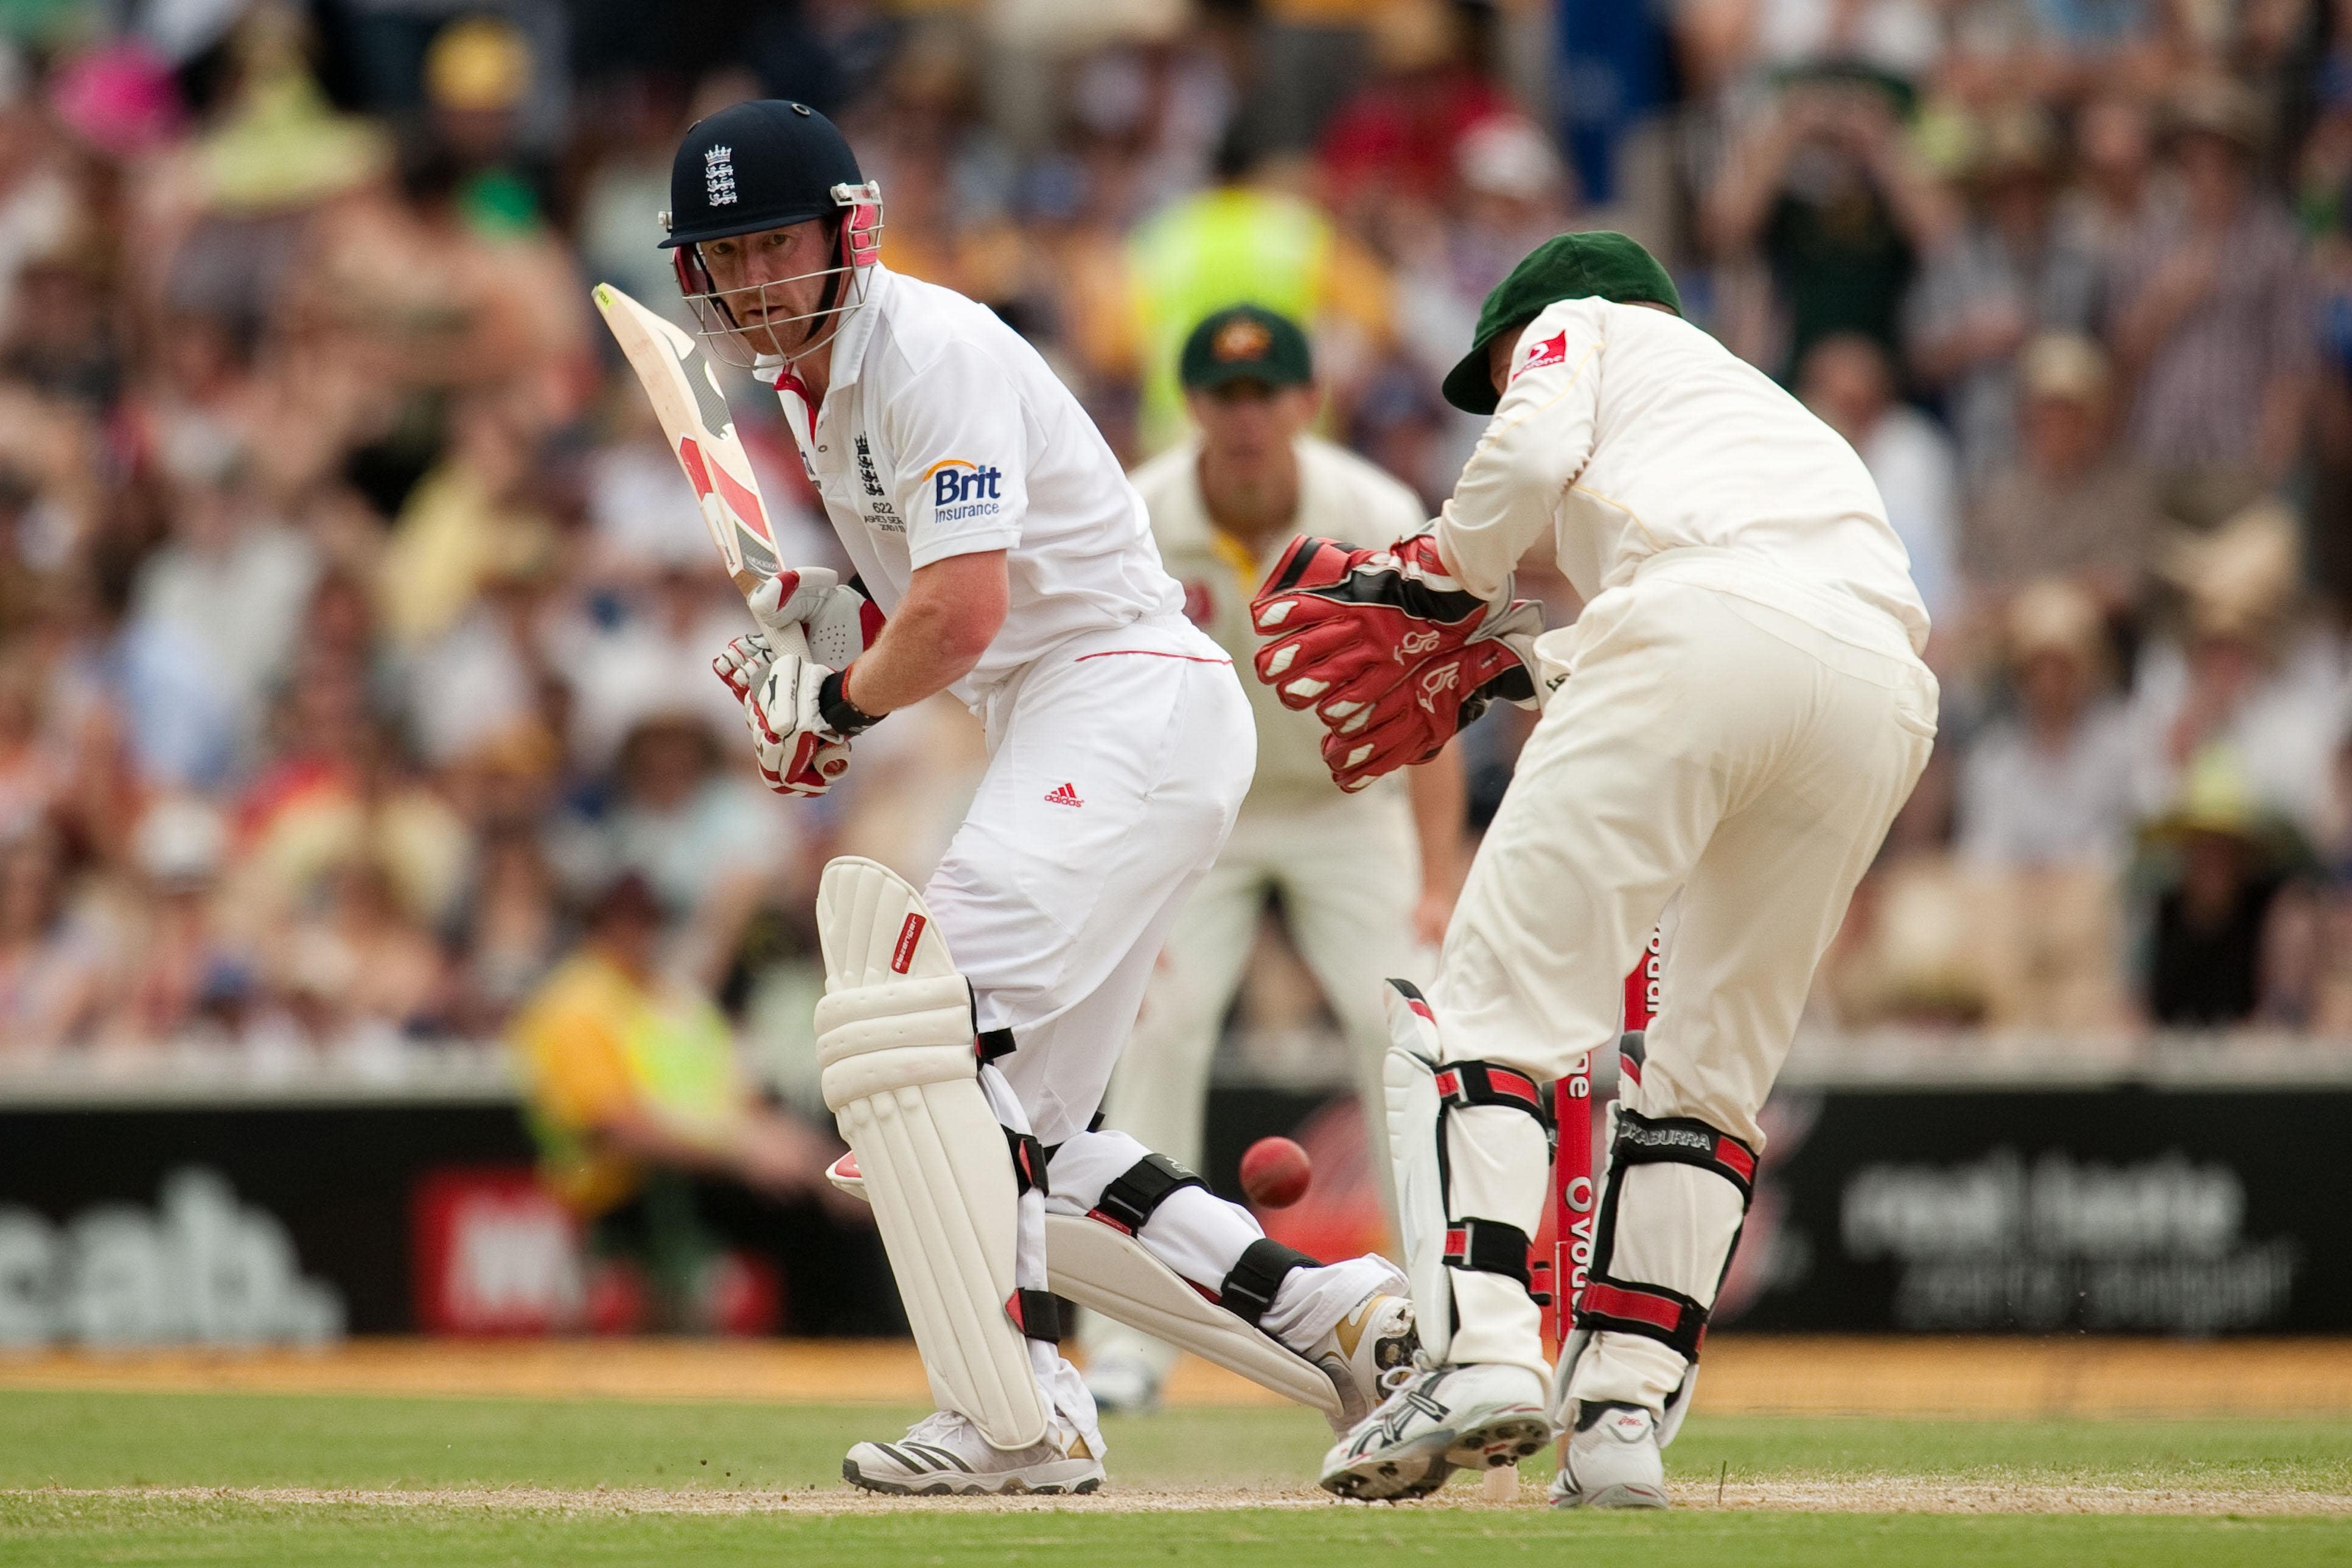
left=924, top=618, right=1369, bottom=1441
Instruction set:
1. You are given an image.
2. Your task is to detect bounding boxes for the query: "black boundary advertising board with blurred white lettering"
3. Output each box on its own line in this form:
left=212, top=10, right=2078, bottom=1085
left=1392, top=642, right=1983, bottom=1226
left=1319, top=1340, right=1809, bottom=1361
left=0, top=1070, right=2352, bottom=1345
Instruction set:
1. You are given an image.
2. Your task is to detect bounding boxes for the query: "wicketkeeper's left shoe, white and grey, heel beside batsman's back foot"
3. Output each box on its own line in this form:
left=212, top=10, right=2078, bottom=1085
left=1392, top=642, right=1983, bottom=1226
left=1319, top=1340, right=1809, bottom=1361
left=1322, top=1361, right=1552, bottom=1502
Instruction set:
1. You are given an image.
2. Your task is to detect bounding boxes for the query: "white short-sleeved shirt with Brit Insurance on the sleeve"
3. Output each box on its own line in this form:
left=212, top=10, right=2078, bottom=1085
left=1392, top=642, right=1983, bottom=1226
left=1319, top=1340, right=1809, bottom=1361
left=759, top=263, right=1183, bottom=713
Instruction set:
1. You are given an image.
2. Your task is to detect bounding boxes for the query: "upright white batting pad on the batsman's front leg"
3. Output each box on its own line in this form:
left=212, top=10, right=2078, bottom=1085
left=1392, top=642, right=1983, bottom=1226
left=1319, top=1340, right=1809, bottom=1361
left=816, top=855, right=1047, bottom=1448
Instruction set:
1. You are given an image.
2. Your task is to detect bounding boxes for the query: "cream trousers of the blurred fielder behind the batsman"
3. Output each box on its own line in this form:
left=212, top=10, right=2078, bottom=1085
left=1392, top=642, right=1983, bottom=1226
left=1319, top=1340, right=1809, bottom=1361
left=1080, top=787, right=1428, bottom=1378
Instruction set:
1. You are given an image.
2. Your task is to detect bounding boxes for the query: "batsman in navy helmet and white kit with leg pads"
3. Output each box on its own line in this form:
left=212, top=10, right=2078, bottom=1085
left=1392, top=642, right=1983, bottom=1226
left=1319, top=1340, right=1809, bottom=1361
left=663, top=99, right=1414, bottom=1495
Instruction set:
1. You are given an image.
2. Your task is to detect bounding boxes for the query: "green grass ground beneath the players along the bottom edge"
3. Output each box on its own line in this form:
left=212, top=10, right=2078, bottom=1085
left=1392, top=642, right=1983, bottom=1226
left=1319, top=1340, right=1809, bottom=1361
left=0, top=1392, right=2352, bottom=1568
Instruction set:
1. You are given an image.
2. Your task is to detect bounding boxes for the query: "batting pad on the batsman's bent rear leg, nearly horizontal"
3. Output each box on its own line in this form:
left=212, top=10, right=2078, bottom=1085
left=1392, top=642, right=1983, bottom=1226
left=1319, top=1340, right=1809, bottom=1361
left=1044, top=1213, right=1341, bottom=1422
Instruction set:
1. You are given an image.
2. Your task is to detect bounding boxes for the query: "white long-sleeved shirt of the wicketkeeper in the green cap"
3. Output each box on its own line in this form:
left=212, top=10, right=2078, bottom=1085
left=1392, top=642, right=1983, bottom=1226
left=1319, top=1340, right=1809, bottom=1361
left=1437, top=299, right=1928, bottom=651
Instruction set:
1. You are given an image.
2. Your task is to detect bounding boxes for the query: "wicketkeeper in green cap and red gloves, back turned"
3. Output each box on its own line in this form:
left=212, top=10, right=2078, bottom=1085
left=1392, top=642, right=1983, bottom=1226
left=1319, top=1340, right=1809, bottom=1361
left=1254, top=232, right=1936, bottom=1507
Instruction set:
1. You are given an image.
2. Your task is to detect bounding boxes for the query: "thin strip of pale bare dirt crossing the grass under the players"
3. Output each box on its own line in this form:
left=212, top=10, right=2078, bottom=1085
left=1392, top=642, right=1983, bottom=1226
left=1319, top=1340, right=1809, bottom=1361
left=18, top=1476, right=2352, bottom=1516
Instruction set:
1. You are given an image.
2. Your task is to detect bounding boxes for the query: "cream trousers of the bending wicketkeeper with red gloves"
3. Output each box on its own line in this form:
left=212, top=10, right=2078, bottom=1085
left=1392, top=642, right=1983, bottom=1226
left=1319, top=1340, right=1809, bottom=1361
left=1430, top=550, right=1936, bottom=1408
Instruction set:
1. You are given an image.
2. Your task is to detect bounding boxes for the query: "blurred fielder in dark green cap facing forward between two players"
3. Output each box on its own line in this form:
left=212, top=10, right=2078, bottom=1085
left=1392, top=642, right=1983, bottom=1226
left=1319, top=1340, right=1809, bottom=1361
left=1080, top=303, right=1465, bottom=1410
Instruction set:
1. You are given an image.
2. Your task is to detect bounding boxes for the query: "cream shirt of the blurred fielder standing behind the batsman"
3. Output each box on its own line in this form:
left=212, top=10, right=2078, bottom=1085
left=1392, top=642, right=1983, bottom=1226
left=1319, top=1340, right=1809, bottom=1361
left=1129, top=435, right=1425, bottom=806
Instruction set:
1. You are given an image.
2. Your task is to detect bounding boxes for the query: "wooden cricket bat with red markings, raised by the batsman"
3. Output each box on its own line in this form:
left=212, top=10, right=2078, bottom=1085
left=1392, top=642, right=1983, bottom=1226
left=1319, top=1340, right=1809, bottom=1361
left=593, top=282, right=809, bottom=658
